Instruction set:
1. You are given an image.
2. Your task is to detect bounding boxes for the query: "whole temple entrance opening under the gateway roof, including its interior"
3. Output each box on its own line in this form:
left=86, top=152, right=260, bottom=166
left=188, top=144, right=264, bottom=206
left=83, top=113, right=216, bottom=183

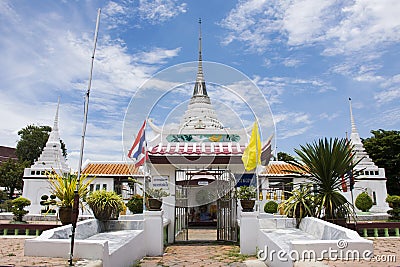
left=175, top=169, right=237, bottom=242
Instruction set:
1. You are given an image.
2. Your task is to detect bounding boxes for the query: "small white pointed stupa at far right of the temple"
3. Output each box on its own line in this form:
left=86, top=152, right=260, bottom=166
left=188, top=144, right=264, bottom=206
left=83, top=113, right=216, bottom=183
left=344, top=99, right=389, bottom=213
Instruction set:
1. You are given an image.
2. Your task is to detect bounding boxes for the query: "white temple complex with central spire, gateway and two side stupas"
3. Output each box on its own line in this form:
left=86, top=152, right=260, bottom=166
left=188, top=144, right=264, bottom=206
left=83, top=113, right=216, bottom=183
left=18, top=21, right=388, bottom=242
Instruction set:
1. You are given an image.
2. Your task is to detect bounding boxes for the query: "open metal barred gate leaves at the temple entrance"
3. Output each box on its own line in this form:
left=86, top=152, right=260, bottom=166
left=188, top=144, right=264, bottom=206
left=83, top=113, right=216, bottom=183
left=175, top=169, right=237, bottom=242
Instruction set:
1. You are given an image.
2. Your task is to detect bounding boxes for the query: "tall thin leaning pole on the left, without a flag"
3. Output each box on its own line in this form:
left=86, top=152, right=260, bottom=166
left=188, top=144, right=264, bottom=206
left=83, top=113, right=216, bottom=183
left=69, top=8, right=101, bottom=266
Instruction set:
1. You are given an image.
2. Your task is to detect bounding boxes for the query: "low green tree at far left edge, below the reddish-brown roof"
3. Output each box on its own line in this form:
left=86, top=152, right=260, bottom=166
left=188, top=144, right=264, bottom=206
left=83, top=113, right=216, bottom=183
left=0, top=159, right=29, bottom=198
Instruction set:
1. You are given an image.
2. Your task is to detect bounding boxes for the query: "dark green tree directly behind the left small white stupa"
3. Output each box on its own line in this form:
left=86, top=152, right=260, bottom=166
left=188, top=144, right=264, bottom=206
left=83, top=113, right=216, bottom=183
left=15, top=125, right=67, bottom=165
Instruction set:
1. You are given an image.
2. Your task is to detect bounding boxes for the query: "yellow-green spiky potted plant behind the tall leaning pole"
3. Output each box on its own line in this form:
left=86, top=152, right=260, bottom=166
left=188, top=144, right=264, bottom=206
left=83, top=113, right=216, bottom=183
left=47, top=171, right=95, bottom=225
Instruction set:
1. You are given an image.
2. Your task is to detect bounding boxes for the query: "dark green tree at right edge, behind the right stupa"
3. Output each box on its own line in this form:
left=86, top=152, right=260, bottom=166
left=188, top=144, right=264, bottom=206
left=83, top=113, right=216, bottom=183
left=363, top=129, right=400, bottom=195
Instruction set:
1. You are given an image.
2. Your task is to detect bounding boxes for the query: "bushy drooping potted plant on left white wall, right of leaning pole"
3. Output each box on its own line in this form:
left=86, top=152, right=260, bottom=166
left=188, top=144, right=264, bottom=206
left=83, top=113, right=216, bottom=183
left=86, top=190, right=126, bottom=221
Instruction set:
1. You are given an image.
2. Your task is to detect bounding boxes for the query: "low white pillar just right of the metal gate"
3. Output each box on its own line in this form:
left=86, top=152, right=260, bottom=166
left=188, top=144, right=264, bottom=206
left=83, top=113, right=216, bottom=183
left=240, top=212, right=259, bottom=255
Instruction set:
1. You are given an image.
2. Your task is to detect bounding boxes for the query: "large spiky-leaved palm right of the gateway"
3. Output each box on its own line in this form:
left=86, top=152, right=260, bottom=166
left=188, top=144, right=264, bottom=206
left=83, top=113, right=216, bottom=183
left=289, top=138, right=359, bottom=220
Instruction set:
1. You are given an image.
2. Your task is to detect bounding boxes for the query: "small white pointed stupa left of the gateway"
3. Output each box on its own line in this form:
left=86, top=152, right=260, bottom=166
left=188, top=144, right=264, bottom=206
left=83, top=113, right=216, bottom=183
left=22, top=102, right=69, bottom=214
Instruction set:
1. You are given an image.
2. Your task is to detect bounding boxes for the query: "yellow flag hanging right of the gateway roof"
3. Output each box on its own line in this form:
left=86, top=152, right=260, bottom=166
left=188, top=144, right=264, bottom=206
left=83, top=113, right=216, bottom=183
left=242, top=121, right=261, bottom=171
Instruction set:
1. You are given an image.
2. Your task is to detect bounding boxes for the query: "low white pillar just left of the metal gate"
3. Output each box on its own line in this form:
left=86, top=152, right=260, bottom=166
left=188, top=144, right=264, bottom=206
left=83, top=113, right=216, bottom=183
left=144, top=210, right=164, bottom=256
